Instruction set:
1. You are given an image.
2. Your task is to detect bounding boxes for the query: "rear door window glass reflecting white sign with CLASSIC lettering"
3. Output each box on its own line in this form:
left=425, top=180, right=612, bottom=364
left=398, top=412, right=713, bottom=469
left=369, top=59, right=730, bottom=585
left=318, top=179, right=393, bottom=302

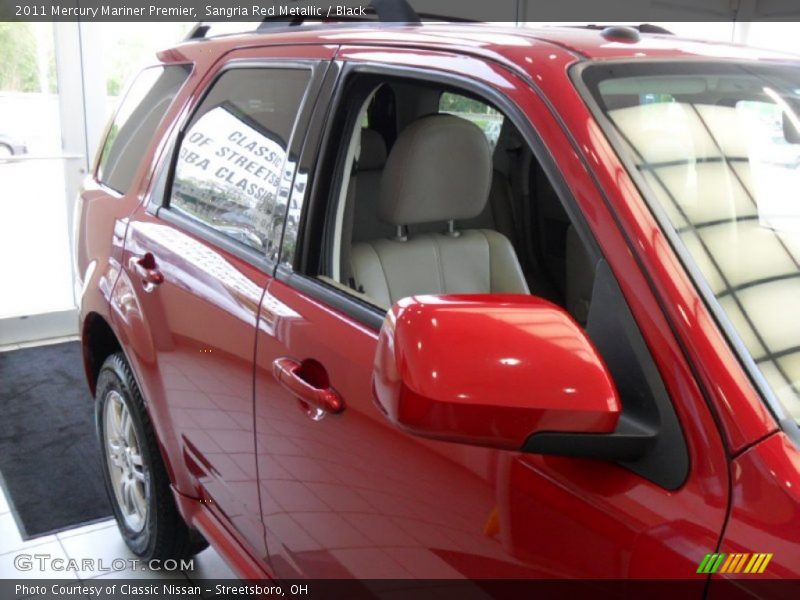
left=169, top=68, right=311, bottom=251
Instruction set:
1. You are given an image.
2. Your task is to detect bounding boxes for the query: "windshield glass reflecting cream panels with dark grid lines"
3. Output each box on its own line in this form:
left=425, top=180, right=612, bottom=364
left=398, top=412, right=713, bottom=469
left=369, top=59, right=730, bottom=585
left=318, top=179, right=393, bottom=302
left=590, top=64, right=800, bottom=421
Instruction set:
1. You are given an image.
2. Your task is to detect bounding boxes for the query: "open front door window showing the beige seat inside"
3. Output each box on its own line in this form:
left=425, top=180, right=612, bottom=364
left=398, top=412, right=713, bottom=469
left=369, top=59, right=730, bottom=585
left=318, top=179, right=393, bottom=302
left=304, top=77, right=580, bottom=316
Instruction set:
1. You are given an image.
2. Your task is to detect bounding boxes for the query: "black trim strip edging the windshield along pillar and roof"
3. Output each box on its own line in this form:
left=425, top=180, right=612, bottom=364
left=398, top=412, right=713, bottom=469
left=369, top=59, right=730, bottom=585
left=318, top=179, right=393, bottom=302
left=568, top=58, right=800, bottom=447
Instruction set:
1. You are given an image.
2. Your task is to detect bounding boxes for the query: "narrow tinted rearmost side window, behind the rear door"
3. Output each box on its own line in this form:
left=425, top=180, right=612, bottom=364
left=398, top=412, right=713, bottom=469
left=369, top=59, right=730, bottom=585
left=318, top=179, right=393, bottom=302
left=97, top=65, right=191, bottom=194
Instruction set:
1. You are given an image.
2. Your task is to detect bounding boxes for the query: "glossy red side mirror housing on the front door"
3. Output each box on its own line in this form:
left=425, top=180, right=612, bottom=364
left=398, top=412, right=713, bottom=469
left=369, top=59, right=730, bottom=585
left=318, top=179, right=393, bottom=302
left=373, top=295, right=622, bottom=454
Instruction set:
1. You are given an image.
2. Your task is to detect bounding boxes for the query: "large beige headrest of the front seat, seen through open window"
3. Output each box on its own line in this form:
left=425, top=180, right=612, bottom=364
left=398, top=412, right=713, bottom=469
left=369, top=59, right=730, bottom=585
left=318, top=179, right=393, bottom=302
left=378, top=114, right=492, bottom=225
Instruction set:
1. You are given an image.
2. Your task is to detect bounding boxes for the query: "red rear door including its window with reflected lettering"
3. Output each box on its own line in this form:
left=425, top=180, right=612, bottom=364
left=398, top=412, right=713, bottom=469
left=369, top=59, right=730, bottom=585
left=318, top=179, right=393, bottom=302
left=115, top=48, right=332, bottom=559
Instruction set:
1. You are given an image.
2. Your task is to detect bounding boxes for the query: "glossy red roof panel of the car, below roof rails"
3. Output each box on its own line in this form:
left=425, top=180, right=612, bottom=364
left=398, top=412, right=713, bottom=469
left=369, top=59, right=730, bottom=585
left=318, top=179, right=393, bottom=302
left=164, top=22, right=800, bottom=61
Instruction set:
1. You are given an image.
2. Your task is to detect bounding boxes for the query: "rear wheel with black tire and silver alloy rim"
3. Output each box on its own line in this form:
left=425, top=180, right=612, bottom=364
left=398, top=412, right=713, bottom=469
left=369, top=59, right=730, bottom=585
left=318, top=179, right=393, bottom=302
left=95, top=352, right=208, bottom=561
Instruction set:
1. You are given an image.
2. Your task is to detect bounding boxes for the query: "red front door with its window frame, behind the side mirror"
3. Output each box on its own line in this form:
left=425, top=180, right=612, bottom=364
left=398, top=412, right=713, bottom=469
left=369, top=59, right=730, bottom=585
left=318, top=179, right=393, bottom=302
left=255, top=44, right=728, bottom=579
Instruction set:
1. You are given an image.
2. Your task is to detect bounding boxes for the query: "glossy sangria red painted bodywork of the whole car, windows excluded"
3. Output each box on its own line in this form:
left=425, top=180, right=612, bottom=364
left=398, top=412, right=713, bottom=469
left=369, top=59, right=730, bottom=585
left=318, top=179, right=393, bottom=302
left=77, top=25, right=800, bottom=584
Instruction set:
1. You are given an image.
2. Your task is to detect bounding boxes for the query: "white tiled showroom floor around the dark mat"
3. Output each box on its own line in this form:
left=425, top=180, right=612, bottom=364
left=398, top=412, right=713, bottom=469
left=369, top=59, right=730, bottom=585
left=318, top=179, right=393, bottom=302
left=0, top=338, right=235, bottom=581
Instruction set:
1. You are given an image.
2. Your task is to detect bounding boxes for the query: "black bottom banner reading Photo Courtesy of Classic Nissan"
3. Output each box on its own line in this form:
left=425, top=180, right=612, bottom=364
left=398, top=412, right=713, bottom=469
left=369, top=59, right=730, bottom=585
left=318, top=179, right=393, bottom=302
left=0, top=576, right=800, bottom=600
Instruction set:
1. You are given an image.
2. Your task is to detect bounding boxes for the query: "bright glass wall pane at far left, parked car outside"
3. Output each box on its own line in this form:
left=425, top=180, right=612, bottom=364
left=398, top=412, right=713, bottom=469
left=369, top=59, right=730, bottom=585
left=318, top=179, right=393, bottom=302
left=0, top=23, right=74, bottom=319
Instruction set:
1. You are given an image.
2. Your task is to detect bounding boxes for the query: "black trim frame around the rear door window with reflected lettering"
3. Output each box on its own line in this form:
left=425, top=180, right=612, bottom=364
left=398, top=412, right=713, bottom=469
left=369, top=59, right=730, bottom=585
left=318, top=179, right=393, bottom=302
left=146, top=58, right=331, bottom=275
